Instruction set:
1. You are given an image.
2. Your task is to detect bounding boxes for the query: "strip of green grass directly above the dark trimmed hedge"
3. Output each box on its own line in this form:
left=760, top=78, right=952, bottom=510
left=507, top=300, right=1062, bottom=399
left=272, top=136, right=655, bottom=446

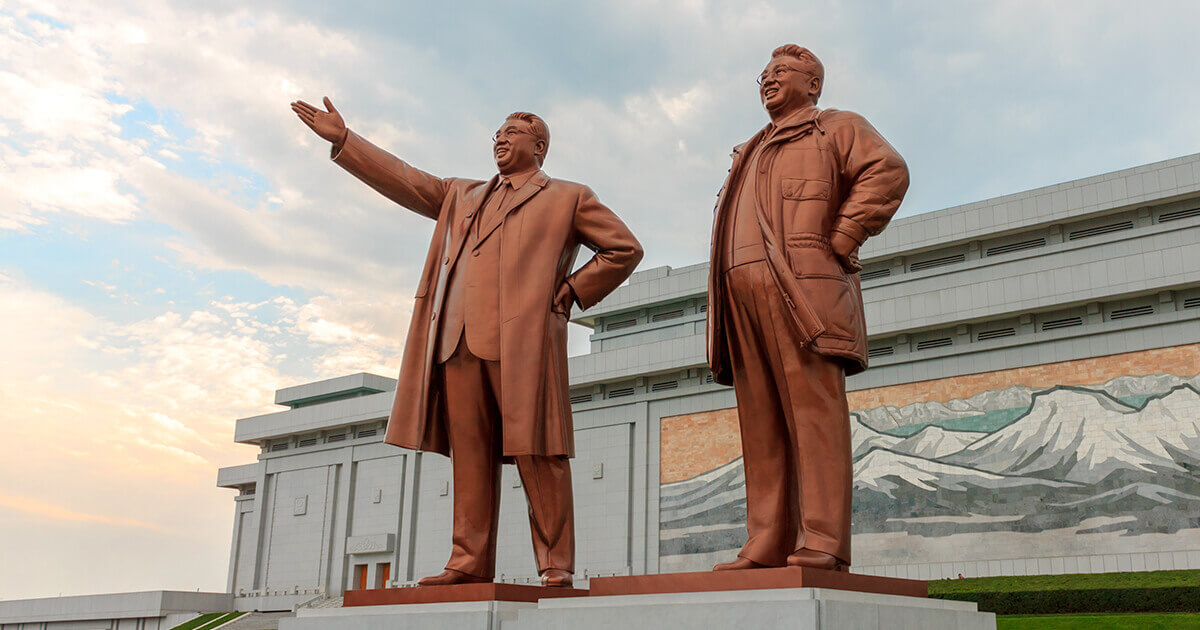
left=929, top=570, right=1200, bottom=598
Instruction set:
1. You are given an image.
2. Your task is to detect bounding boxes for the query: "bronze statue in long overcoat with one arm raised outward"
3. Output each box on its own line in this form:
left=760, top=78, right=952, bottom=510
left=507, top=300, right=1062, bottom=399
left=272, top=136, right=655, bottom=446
left=292, top=98, right=642, bottom=587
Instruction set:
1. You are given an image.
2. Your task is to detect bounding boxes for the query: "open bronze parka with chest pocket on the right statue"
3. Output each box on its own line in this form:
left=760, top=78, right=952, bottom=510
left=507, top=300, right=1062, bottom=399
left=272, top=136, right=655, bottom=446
left=708, top=107, right=908, bottom=385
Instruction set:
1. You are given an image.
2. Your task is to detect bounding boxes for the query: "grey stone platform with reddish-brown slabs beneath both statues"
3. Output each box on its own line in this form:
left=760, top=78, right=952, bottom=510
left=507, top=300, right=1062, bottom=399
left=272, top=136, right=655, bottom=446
left=280, top=568, right=996, bottom=630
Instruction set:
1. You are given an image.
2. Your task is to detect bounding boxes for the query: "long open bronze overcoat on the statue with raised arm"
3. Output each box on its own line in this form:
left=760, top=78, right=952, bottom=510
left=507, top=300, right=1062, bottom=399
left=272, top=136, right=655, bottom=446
left=332, top=132, right=642, bottom=456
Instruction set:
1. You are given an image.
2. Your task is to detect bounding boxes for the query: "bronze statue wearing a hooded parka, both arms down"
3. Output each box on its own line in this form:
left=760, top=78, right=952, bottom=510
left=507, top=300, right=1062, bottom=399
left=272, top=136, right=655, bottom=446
left=708, top=44, right=908, bottom=570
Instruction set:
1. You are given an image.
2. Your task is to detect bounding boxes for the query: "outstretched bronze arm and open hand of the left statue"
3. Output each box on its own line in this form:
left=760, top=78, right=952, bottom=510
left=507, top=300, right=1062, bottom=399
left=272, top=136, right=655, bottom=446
left=292, top=97, right=449, bottom=220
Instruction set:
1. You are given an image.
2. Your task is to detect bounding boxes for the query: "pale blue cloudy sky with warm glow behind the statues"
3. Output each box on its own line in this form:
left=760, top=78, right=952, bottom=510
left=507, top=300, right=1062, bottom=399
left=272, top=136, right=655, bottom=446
left=0, top=0, right=1200, bottom=599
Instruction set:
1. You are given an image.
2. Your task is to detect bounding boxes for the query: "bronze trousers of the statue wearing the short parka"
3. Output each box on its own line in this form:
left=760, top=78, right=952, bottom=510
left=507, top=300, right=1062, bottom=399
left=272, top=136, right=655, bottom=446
left=721, top=262, right=852, bottom=566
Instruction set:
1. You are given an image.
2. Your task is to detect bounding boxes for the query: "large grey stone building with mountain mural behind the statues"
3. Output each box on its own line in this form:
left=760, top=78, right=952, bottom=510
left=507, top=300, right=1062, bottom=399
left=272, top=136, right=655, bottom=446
left=218, top=150, right=1200, bottom=610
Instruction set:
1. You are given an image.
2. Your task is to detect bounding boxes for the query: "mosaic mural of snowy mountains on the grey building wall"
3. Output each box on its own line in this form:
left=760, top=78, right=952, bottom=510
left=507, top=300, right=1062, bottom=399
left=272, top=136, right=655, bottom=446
left=660, top=347, right=1200, bottom=570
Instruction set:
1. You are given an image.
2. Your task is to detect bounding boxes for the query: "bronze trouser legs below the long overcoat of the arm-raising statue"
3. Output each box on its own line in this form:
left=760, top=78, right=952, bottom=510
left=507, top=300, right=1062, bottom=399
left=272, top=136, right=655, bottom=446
left=442, top=338, right=575, bottom=578
